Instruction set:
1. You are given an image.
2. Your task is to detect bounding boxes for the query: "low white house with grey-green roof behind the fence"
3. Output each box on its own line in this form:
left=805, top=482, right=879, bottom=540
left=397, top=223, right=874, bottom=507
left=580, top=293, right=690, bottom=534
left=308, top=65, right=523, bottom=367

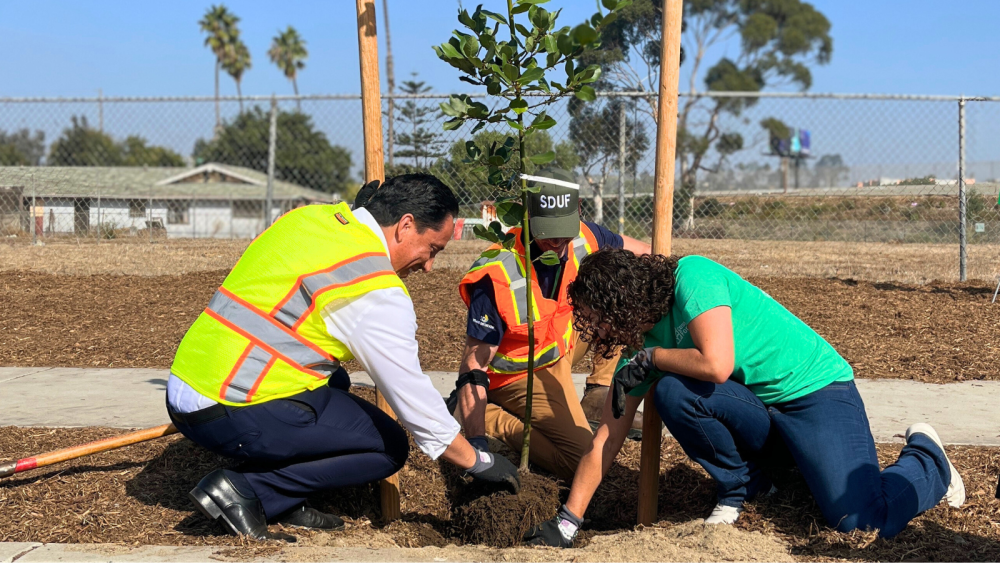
left=0, top=163, right=336, bottom=238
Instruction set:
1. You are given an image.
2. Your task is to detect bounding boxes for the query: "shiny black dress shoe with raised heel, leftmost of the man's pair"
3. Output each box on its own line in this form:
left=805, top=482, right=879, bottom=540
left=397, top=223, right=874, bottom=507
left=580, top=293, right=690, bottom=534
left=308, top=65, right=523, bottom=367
left=188, top=469, right=295, bottom=542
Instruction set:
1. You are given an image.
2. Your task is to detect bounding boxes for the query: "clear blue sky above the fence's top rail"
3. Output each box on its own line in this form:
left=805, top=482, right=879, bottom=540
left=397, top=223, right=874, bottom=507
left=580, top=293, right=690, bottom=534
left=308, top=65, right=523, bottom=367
left=0, top=0, right=1000, bottom=96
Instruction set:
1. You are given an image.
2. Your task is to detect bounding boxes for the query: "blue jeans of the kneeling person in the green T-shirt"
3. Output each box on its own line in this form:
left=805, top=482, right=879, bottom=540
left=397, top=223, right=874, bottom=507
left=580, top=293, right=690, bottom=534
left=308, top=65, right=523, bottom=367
left=655, top=374, right=951, bottom=537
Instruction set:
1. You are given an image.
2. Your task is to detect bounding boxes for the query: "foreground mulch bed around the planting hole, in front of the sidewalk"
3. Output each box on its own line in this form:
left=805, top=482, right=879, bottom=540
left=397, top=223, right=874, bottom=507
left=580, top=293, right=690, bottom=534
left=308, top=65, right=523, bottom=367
left=0, top=388, right=1000, bottom=561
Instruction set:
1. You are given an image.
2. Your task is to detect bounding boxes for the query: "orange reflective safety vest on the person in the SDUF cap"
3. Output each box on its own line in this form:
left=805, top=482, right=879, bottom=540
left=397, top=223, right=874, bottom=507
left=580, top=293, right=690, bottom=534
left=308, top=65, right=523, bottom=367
left=458, top=222, right=597, bottom=389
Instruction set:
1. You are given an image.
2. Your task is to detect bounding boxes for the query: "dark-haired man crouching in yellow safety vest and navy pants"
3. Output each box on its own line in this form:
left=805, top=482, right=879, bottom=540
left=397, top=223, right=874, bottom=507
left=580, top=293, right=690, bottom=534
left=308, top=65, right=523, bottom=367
left=167, top=174, right=519, bottom=541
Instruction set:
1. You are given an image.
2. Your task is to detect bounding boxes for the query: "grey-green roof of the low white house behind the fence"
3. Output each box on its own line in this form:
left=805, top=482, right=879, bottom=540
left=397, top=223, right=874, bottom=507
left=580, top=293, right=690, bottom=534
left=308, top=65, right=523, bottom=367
left=0, top=163, right=337, bottom=201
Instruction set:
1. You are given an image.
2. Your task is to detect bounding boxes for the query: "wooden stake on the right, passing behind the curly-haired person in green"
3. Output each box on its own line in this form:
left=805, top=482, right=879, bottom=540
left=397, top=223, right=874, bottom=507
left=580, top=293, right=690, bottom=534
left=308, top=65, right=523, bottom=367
left=638, top=0, right=684, bottom=526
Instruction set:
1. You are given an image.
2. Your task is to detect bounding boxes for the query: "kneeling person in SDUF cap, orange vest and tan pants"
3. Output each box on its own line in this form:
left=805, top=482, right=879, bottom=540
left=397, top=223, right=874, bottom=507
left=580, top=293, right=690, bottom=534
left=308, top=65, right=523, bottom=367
left=454, top=170, right=650, bottom=478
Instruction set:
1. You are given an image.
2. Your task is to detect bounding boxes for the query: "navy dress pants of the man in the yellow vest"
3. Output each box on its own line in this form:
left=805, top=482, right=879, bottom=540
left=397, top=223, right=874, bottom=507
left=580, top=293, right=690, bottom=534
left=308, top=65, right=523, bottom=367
left=174, top=369, right=409, bottom=518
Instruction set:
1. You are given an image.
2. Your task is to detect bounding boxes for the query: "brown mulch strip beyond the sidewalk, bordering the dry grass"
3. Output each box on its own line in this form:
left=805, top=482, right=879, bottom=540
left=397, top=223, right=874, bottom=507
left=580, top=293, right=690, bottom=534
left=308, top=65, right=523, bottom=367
left=0, top=270, right=1000, bottom=383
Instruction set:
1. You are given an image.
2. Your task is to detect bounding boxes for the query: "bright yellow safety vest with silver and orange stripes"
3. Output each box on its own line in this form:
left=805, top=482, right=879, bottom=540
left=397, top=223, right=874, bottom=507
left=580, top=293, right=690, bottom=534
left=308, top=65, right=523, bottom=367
left=170, top=203, right=409, bottom=406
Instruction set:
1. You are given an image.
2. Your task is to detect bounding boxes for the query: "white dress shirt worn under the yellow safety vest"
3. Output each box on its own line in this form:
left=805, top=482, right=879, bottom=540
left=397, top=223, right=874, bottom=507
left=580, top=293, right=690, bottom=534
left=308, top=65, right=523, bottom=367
left=167, top=209, right=460, bottom=459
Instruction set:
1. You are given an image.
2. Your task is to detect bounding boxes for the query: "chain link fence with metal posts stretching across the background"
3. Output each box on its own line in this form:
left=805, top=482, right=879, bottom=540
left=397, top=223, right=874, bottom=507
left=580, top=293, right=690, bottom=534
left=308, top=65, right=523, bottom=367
left=0, top=92, right=1000, bottom=279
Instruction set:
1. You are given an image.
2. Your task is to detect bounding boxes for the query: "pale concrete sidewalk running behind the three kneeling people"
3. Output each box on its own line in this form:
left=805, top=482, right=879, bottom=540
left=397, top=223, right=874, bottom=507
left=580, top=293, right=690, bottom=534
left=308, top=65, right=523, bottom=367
left=0, top=367, right=1000, bottom=446
